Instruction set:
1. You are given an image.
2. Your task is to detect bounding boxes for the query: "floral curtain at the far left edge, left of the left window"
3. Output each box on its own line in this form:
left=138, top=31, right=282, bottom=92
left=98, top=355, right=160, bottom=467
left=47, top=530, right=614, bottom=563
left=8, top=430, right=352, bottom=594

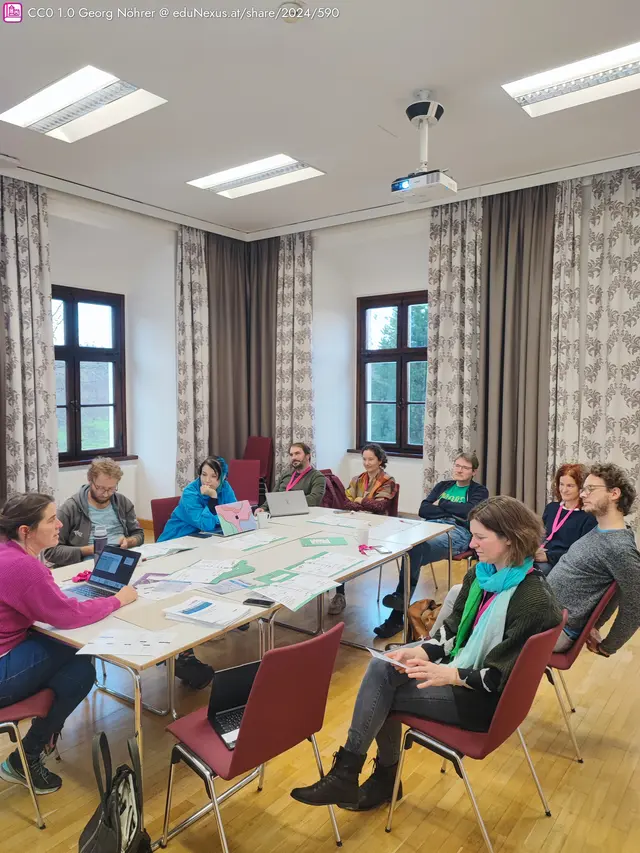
left=0, top=176, right=58, bottom=496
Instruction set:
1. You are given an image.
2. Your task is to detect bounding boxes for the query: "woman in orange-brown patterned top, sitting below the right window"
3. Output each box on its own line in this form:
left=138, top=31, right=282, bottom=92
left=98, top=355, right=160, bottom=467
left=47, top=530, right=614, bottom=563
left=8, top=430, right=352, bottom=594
left=329, top=444, right=398, bottom=616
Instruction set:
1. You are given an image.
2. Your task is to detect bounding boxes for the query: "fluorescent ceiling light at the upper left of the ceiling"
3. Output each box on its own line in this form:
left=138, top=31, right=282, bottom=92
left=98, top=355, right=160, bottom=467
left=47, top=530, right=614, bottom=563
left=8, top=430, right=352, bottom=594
left=0, top=65, right=166, bottom=142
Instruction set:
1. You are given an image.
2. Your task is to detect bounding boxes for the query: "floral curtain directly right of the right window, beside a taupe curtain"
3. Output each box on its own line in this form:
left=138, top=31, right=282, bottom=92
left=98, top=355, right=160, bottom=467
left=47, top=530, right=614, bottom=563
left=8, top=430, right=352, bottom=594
left=423, top=199, right=482, bottom=493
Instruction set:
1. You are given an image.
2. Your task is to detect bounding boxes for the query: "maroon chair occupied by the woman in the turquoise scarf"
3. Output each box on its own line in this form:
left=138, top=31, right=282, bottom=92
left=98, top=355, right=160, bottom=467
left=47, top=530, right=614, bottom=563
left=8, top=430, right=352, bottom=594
left=387, top=611, right=567, bottom=853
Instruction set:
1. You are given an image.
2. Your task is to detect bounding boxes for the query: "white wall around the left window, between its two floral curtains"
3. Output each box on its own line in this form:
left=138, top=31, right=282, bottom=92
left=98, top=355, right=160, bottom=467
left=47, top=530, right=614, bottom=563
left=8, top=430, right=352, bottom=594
left=49, top=192, right=177, bottom=519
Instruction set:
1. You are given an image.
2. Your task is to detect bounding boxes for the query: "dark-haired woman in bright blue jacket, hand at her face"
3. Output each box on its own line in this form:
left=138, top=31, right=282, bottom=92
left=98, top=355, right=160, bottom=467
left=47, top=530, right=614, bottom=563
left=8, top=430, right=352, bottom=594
left=158, top=456, right=236, bottom=542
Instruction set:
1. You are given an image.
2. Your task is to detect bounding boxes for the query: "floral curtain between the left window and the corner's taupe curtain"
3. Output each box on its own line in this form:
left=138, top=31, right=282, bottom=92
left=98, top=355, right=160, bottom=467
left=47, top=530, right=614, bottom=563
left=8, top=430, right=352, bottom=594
left=176, top=226, right=209, bottom=491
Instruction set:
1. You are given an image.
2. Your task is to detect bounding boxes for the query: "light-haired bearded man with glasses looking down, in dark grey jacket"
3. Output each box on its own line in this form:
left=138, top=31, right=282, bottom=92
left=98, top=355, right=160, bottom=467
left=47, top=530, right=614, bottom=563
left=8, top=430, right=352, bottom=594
left=44, top=457, right=144, bottom=567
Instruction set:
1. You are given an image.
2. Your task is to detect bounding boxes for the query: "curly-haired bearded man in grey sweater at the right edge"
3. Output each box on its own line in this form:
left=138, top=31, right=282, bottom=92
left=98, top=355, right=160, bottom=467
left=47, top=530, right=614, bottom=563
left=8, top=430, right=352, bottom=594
left=547, top=463, right=640, bottom=657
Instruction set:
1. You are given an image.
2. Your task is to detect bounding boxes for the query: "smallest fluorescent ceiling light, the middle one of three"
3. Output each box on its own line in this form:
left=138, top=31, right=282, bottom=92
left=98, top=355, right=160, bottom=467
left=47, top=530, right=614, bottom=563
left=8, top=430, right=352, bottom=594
left=187, top=154, right=324, bottom=198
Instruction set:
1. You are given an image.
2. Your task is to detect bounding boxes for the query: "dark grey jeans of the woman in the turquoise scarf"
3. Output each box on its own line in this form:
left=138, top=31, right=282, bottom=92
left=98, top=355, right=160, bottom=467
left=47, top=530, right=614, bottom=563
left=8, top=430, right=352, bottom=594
left=345, top=643, right=468, bottom=767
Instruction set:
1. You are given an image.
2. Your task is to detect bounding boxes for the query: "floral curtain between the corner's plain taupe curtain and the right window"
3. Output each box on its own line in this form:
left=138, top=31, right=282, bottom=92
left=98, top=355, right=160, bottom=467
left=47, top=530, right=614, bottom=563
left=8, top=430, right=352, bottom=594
left=274, top=232, right=314, bottom=477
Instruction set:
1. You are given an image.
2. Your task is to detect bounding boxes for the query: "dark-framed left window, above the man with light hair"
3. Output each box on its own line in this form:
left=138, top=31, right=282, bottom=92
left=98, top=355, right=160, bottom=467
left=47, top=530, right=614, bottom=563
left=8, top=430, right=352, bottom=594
left=51, top=285, right=127, bottom=463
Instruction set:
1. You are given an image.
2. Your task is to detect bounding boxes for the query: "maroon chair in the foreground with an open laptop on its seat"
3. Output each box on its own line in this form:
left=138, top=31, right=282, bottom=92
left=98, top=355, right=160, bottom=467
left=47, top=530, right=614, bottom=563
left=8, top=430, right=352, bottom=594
left=160, top=622, right=344, bottom=853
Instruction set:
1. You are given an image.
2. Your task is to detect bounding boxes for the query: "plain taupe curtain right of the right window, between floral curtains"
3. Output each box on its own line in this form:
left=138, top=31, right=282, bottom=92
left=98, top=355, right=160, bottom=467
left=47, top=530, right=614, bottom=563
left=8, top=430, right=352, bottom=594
left=478, top=184, right=556, bottom=512
